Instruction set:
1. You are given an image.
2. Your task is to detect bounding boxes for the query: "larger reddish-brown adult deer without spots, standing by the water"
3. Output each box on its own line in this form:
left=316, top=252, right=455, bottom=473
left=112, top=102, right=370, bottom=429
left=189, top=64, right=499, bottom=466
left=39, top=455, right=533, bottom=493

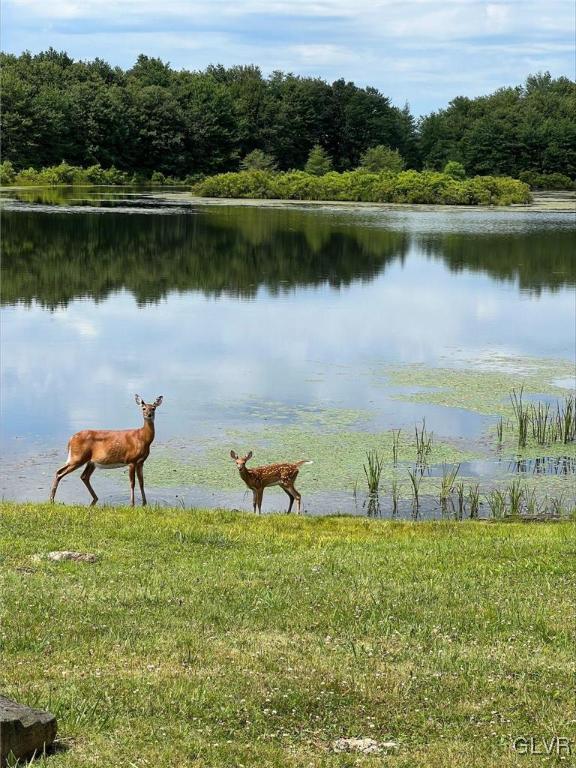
left=50, top=395, right=162, bottom=506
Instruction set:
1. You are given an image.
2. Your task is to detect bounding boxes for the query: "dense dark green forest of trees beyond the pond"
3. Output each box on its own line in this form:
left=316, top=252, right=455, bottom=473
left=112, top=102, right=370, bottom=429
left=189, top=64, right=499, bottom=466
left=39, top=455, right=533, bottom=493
left=0, top=49, right=576, bottom=179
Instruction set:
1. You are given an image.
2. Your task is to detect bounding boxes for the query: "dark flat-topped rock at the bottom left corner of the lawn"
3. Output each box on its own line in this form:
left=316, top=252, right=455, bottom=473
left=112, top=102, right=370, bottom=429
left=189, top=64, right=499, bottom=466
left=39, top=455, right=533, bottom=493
left=0, top=696, right=57, bottom=766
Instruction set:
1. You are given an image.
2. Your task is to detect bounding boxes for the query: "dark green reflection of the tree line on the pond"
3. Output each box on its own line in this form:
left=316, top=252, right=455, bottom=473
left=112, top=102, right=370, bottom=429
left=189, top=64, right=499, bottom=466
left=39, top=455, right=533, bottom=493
left=2, top=208, right=576, bottom=308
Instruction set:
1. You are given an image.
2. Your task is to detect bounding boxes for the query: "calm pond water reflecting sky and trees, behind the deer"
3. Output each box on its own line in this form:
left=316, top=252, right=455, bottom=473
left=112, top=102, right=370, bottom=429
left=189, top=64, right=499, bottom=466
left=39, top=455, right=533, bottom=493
left=0, top=189, right=576, bottom=513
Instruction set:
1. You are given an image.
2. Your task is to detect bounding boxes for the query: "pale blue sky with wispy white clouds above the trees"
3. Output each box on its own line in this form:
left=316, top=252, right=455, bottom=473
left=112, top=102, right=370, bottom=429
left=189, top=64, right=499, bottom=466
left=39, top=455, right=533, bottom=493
left=2, top=0, right=575, bottom=114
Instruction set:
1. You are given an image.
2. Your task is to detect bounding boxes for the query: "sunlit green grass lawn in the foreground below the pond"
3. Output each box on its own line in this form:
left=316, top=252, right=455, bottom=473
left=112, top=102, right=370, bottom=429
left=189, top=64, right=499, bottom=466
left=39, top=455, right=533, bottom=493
left=0, top=503, right=576, bottom=768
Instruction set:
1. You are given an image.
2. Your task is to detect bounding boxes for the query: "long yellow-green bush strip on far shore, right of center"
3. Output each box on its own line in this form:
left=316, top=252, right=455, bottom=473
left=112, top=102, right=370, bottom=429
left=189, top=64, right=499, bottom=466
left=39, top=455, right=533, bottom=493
left=192, top=169, right=531, bottom=205
